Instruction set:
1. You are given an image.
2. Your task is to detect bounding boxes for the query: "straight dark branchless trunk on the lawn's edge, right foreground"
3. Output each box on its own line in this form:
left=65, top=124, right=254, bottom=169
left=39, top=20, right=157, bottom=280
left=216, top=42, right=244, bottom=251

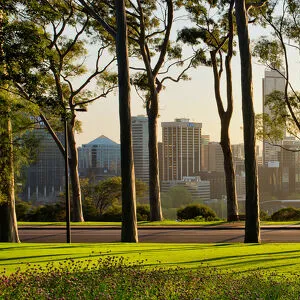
left=235, top=0, right=260, bottom=243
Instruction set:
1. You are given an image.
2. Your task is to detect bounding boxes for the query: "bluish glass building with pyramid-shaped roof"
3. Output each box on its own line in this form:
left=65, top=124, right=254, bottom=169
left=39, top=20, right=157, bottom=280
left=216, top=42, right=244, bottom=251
left=78, top=135, right=121, bottom=179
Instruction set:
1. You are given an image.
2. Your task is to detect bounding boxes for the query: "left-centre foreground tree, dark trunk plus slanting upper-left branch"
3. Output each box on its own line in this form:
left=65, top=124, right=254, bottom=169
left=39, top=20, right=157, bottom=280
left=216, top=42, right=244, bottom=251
left=78, top=0, right=138, bottom=242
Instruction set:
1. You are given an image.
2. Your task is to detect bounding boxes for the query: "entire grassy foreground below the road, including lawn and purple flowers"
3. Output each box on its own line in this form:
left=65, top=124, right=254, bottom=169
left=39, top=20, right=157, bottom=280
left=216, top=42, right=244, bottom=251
left=0, top=243, right=300, bottom=299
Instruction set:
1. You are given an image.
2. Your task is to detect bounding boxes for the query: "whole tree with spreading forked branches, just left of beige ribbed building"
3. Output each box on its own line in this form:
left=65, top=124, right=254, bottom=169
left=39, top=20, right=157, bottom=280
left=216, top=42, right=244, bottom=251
left=127, top=0, right=202, bottom=221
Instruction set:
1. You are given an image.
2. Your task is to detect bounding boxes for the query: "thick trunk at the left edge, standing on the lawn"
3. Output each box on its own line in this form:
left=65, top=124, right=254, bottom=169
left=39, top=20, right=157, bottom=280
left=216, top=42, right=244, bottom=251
left=0, top=105, right=20, bottom=243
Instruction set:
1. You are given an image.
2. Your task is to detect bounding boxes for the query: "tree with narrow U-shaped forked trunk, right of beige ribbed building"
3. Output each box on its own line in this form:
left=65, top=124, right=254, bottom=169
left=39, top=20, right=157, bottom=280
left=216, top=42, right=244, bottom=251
left=179, top=0, right=239, bottom=221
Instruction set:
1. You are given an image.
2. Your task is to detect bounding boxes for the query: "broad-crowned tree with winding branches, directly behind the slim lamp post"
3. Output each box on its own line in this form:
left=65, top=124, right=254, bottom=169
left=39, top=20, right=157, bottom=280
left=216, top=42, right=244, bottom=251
left=2, top=0, right=116, bottom=221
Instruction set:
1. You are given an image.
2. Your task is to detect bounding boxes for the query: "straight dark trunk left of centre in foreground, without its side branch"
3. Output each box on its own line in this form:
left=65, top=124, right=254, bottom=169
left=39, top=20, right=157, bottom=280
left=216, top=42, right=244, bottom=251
left=115, top=0, right=138, bottom=242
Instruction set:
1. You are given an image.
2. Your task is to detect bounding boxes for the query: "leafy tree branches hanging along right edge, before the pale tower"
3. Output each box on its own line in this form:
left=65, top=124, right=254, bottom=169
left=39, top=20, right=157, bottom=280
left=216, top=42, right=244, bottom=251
left=254, top=0, right=300, bottom=144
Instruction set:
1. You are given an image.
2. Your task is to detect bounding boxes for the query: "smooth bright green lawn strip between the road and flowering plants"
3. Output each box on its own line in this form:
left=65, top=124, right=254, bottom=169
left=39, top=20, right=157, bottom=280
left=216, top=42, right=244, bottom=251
left=0, top=243, right=300, bottom=275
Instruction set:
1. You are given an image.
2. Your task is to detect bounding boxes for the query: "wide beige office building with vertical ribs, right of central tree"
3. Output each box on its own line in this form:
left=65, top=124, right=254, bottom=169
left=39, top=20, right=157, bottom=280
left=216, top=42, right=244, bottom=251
left=161, top=119, right=202, bottom=181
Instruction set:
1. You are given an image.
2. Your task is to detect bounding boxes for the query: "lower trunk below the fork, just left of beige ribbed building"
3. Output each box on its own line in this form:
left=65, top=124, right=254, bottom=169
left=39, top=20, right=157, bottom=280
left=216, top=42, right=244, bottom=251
left=148, top=101, right=163, bottom=221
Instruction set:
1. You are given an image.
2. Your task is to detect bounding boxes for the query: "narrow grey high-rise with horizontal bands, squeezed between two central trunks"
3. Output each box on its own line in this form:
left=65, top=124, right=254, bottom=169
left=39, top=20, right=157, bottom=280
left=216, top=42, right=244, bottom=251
left=131, top=115, right=149, bottom=182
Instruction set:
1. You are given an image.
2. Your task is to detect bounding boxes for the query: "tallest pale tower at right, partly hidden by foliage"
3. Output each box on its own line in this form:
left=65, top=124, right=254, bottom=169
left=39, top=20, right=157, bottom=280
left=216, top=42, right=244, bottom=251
left=263, top=70, right=285, bottom=166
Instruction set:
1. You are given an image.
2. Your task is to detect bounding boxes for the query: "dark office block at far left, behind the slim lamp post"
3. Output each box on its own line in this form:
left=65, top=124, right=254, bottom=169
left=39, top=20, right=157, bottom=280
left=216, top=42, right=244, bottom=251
left=21, top=123, right=65, bottom=203
